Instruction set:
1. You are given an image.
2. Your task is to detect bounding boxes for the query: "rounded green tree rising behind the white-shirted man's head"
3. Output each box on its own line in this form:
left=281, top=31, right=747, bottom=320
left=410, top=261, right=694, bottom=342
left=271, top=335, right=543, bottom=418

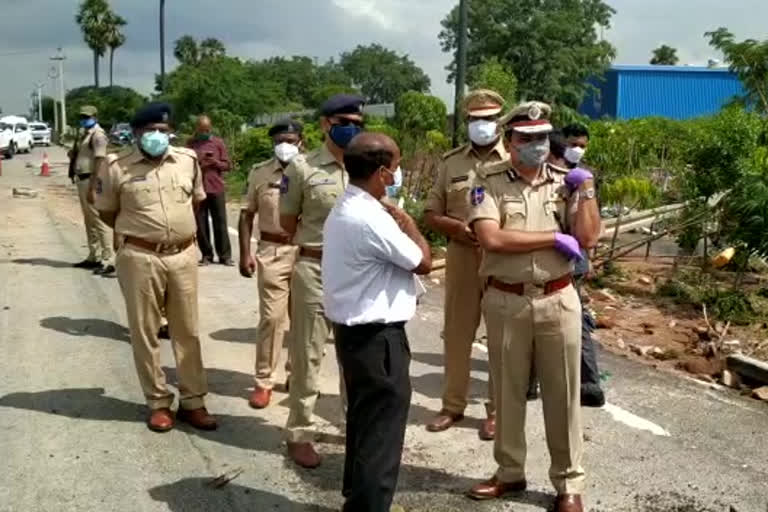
left=340, top=44, right=431, bottom=103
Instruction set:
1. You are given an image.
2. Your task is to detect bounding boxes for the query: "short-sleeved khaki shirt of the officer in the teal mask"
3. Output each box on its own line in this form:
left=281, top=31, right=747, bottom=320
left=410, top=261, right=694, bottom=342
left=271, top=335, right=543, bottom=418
left=95, top=147, right=205, bottom=244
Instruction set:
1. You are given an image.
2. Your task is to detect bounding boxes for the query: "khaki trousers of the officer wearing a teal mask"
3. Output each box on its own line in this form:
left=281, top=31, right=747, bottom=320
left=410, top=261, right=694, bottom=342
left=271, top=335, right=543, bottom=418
left=116, top=245, right=208, bottom=409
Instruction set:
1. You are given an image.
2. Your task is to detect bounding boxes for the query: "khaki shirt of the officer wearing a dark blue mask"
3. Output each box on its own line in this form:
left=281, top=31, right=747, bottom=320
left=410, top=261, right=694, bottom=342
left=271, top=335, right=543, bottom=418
left=280, top=144, right=349, bottom=249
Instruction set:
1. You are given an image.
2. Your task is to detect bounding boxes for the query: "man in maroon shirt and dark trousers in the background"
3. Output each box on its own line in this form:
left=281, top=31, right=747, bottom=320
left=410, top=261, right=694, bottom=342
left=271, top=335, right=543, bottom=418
left=187, top=116, right=234, bottom=267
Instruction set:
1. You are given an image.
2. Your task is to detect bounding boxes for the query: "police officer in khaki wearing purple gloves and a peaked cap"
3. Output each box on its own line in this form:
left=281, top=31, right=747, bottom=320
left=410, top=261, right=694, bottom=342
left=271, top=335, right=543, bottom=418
left=469, top=102, right=600, bottom=512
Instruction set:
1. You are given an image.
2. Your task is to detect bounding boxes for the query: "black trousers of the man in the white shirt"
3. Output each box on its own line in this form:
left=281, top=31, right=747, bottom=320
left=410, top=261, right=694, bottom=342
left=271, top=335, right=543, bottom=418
left=334, top=323, right=411, bottom=512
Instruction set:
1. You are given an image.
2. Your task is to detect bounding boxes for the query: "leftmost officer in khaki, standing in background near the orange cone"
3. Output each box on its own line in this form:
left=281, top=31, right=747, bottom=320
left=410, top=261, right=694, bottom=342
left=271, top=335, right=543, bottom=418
left=70, top=105, right=115, bottom=275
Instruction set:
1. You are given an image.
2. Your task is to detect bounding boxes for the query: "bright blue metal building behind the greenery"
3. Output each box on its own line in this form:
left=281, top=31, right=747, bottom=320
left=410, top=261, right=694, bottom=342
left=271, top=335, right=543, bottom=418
left=579, top=66, right=744, bottom=119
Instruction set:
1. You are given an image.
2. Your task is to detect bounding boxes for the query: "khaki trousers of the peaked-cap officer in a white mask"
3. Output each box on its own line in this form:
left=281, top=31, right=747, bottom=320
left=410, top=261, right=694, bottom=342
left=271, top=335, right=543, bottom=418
left=443, top=242, right=494, bottom=414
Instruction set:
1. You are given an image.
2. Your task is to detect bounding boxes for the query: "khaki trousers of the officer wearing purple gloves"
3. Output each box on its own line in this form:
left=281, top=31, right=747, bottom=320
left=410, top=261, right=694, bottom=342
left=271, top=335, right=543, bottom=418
left=483, top=286, right=584, bottom=494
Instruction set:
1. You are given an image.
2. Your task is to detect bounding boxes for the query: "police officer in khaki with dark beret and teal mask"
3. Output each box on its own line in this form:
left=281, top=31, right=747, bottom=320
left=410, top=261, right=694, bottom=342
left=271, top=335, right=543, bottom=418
left=96, top=103, right=216, bottom=432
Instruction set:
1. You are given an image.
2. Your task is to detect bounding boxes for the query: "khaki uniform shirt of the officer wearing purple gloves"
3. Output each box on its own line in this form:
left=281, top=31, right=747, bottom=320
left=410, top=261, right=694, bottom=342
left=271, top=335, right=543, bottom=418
left=468, top=163, right=573, bottom=285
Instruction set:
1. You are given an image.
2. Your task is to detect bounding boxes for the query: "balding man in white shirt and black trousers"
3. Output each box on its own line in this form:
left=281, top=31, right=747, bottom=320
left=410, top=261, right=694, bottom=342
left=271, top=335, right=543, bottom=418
left=322, top=133, right=432, bottom=512
